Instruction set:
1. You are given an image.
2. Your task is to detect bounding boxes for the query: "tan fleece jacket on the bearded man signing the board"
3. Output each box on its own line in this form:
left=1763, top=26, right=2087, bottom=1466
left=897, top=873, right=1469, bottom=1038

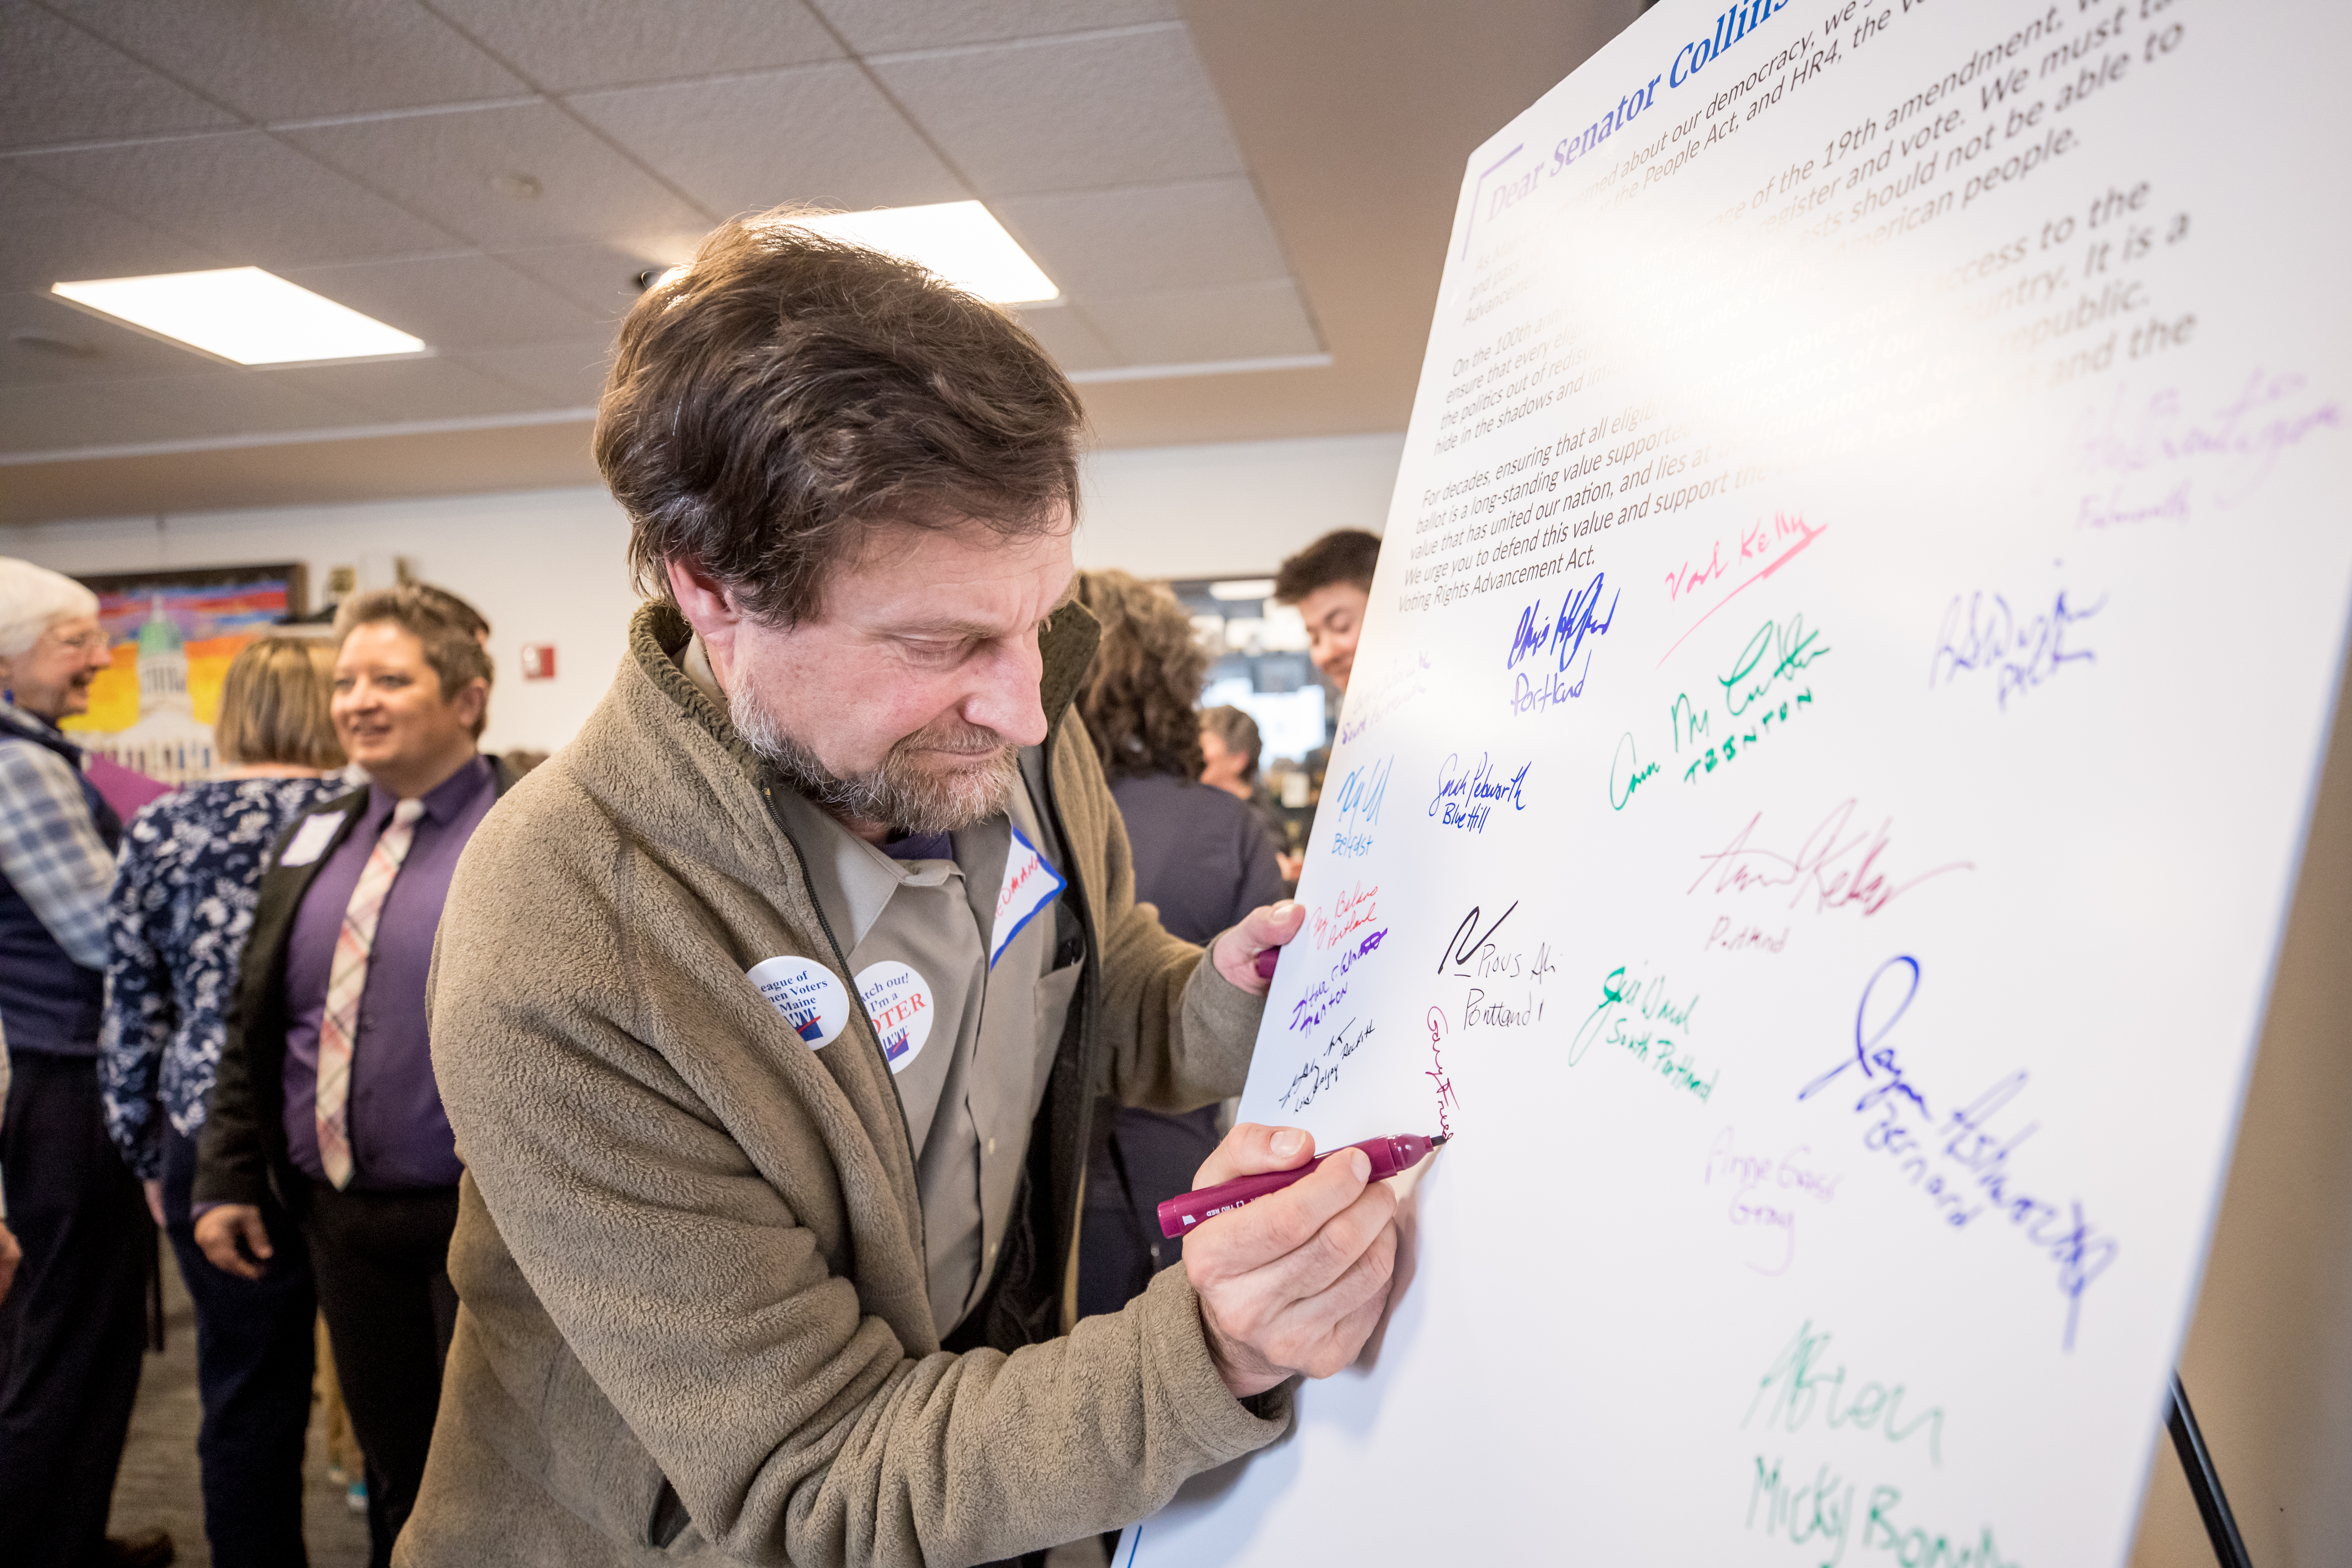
left=395, top=604, right=1289, bottom=1568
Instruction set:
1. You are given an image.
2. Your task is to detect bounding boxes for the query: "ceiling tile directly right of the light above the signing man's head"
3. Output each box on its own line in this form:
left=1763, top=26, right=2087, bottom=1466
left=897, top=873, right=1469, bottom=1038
left=990, top=179, right=1287, bottom=294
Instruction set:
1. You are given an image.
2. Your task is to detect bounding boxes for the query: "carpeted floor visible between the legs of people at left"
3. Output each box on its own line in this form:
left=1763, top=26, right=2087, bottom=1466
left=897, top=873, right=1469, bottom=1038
left=108, top=1248, right=367, bottom=1568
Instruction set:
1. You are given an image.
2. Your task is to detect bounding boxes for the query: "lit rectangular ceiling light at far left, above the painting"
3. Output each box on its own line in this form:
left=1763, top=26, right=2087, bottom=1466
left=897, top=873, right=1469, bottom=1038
left=50, top=266, right=423, bottom=364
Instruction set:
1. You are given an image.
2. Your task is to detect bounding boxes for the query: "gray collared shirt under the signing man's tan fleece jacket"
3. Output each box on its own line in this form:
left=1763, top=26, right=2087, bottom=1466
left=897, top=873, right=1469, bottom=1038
left=680, top=639, right=1080, bottom=1338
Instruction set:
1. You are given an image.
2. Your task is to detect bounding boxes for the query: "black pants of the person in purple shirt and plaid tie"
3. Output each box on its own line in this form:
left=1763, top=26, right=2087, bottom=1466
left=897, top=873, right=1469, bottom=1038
left=303, top=1182, right=456, bottom=1568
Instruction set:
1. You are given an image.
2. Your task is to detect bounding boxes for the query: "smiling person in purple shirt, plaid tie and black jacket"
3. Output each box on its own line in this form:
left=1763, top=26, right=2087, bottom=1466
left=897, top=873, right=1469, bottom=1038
left=193, top=586, right=508, bottom=1568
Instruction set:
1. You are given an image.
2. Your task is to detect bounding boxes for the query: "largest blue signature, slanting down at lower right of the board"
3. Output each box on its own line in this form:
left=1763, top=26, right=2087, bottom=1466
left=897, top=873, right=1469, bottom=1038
left=1797, top=955, right=2121, bottom=1352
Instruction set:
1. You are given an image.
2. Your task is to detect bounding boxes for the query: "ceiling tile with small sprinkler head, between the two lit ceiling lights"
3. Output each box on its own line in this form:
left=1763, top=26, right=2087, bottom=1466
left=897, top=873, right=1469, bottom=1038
left=280, top=103, right=708, bottom=247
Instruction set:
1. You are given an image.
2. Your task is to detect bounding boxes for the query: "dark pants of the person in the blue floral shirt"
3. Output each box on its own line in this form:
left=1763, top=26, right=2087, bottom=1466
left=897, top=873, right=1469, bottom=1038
left=162, top=1126, right=318, bottom=1568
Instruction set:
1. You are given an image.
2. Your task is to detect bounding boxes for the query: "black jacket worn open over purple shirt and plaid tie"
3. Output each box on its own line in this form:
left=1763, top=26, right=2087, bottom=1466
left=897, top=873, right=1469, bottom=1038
left=191, top=759, right=515, bottom=1213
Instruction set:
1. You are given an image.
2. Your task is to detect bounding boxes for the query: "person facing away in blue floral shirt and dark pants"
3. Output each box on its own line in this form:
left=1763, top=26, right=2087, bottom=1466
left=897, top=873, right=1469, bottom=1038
left=99, top=637, right=351, bottom=1568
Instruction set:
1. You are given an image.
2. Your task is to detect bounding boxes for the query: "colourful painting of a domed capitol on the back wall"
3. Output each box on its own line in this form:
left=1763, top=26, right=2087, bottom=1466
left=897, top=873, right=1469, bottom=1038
left=64, top=564, right=303, bottom=785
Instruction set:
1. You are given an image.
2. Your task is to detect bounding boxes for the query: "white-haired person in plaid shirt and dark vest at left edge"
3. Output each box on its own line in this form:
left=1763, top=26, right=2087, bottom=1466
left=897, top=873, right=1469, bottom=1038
left=0, top=557, right=172, bottom=1568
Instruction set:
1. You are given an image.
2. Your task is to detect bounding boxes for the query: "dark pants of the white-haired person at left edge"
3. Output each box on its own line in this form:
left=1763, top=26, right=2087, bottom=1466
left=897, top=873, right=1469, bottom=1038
left=0, top=1051, right=155, bottom=1568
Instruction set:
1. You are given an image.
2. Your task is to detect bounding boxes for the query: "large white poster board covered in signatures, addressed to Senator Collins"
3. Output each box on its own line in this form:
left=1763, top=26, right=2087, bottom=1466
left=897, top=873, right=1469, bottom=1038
left=1120, top=0, right=2352, bottom=1568
